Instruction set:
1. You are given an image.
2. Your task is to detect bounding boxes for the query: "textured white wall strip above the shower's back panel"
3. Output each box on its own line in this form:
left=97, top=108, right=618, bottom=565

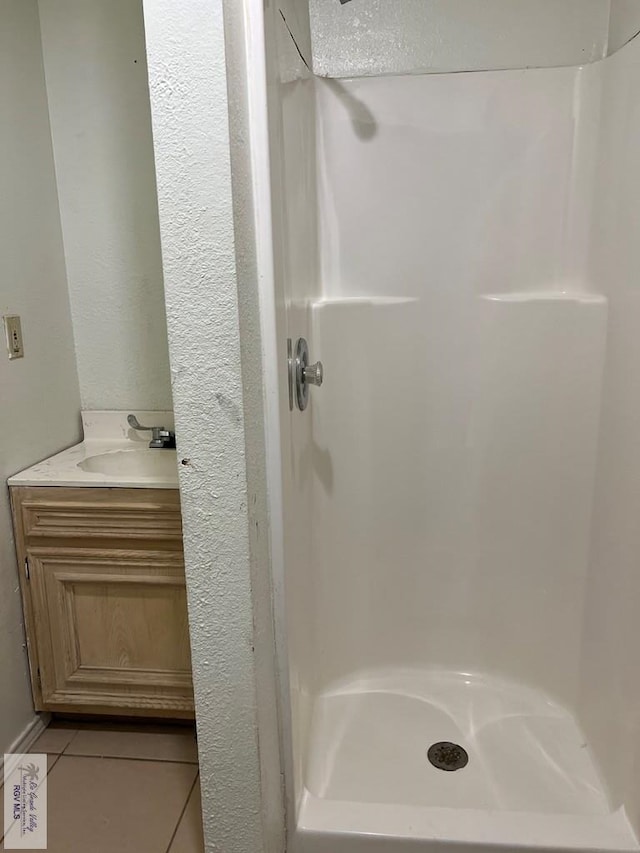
left=310, top=0, right=610, bottom=77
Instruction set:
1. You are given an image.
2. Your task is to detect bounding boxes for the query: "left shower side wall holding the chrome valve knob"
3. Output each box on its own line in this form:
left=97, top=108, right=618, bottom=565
left=265, top=0, right=319, bottom=816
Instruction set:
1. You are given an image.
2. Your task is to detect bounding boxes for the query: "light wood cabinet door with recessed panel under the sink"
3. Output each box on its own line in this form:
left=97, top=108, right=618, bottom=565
left=28, top=548, right=193, bottom=713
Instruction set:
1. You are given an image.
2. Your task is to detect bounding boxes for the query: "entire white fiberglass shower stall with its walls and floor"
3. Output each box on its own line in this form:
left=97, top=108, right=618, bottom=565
left=254, top=0, right=640, bottom=853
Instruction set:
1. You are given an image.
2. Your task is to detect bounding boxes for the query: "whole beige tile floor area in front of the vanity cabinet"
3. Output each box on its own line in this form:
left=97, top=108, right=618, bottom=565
left=0, top=721, right=204, bottom=853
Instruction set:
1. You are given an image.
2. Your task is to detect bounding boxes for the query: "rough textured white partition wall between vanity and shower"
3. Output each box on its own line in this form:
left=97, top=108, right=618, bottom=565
left=144, top=0, right=283, bottom=853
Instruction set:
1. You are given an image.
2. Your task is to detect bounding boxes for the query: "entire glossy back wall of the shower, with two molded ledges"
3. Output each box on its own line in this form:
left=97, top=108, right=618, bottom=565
left=312, top=69, right=607, bottom=707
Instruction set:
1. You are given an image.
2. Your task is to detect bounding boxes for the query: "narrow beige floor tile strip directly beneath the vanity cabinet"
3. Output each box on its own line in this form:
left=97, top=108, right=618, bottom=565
left=65, top=729, right=198, bottom=764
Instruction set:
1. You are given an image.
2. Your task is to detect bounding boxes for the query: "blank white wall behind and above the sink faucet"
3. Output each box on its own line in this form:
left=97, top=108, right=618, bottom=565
left=39, top=0, right=172, bottom=409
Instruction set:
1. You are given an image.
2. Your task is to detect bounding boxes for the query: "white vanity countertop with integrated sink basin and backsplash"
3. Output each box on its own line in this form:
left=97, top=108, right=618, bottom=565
left=8, top=411, right=178, bottom=489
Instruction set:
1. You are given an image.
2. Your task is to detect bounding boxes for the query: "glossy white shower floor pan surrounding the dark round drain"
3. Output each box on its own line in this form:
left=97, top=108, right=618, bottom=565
left=293, top=671, right=640, bottom=853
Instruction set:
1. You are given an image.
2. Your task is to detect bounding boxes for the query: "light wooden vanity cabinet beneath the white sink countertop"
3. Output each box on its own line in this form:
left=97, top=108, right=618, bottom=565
left=11, top=486, right=194, bottom=718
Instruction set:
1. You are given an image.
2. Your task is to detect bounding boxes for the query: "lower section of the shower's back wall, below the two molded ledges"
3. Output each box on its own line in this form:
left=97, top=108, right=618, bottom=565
left=310, top=295, right=607, bottom=707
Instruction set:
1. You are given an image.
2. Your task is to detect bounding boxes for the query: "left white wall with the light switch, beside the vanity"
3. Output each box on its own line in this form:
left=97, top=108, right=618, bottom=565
left=0, top=0, right=80, bottom=751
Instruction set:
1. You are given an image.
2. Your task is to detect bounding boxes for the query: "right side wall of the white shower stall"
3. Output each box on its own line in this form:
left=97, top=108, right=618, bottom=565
left=579, top=33, right=640, bottom=831
